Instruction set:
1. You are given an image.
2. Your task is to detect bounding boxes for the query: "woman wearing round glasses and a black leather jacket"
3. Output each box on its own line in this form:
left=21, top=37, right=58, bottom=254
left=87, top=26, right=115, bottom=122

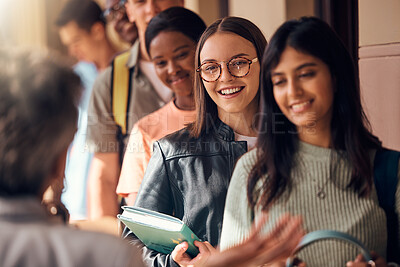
left=128, top=17, right=300, bottom=266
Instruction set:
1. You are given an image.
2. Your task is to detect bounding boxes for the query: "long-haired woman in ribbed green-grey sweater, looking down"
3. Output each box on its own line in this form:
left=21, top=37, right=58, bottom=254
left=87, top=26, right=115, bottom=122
left=221, top=18, right=400, bottom=267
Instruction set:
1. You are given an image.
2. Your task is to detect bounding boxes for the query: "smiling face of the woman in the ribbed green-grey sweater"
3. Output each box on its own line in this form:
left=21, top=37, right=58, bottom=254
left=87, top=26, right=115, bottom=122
left=271, top=46, right=334, bottom=134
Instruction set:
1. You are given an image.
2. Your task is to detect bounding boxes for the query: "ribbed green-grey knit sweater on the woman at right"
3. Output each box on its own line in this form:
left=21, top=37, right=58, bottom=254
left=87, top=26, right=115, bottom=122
left=220, top=142, right=400, bottom=267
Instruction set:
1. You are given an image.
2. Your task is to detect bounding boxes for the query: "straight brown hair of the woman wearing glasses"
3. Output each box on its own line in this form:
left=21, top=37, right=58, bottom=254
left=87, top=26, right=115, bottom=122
left=188, top=17, right=267, bottom=137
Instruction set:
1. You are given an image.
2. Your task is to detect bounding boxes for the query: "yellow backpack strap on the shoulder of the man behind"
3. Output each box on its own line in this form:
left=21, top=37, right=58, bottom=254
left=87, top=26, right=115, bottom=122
left=111, top=51, right=132, bottom=136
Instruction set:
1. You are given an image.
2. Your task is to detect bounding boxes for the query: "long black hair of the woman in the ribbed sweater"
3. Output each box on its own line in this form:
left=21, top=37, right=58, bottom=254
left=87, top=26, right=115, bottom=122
left=247, top=17, right=381, bottom=209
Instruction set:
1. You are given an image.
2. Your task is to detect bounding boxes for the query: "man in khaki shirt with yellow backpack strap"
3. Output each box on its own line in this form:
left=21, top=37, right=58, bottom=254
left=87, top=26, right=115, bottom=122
left=87, top=0, right=183, bottom=219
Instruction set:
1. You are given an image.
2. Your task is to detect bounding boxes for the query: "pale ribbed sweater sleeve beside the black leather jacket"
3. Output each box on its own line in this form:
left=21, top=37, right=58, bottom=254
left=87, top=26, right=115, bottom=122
left=220, top=150, right=255, bottom=250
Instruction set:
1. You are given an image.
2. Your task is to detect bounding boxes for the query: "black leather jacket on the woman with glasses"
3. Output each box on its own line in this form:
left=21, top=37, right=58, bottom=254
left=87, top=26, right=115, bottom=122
left=126, top=120, right=247, bottom=266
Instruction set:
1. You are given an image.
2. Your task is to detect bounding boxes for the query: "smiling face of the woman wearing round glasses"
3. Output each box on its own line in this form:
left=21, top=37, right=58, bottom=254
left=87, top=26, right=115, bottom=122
left=200, top=32, right=260, bottom=118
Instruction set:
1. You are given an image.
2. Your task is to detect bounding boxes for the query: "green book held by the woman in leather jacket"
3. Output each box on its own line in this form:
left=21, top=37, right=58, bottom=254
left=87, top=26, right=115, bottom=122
left=117, top=206, right=200, bottom=257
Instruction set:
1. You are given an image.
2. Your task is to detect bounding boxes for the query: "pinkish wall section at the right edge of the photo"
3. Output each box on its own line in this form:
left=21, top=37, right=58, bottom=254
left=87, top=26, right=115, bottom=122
left=359, top=0, right=400, bottom=150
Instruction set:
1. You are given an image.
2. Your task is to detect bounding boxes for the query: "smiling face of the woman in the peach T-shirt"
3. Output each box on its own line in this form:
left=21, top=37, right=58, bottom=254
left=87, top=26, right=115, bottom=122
left=149, top=32, right=196, bottom=96
